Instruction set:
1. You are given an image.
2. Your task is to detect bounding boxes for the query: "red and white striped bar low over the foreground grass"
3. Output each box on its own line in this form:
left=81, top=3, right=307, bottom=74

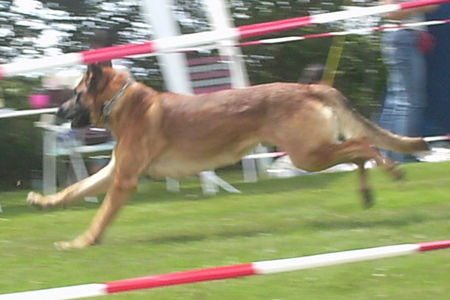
left=0, top=240, right=450, bottom=300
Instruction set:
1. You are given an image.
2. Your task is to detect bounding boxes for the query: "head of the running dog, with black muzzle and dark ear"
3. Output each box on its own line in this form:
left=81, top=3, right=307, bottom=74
left=56, top=64, right=129, bottom=128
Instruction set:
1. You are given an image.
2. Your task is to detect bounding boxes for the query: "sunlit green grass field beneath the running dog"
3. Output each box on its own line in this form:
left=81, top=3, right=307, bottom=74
left=0, top=163, right=450, bottom=300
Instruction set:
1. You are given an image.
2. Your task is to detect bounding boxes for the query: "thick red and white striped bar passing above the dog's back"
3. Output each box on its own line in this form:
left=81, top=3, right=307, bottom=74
left=0, top=0, right=450, bottom=78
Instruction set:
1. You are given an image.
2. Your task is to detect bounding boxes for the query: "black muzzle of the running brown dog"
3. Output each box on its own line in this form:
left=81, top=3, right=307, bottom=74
left=56, top=93, right=91, bottom=128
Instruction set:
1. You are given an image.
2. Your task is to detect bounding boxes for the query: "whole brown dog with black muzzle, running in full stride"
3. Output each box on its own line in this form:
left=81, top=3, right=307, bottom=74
left=28, top=65, right=428, bottom=249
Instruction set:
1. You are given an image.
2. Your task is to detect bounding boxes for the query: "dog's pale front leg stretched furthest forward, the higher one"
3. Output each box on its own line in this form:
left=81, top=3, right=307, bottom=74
left=27, top=154, right=115, bottom=207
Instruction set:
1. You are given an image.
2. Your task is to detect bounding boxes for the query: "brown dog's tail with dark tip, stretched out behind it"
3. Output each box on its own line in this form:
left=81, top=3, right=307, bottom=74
left=316, top=88, right=429, bottom=153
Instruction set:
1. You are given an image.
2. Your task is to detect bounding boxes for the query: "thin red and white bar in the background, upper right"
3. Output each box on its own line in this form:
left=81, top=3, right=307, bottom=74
left=236, top=19, right=450, bottom=47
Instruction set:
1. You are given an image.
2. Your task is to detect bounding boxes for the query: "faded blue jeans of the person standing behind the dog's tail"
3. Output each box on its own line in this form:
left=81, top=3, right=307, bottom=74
left=380, top=29, right=426, bottom=162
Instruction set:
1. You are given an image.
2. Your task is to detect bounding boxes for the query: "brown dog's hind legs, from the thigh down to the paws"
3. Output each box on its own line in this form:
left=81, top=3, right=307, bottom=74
left=272, top=105, right=395, bottom=207
